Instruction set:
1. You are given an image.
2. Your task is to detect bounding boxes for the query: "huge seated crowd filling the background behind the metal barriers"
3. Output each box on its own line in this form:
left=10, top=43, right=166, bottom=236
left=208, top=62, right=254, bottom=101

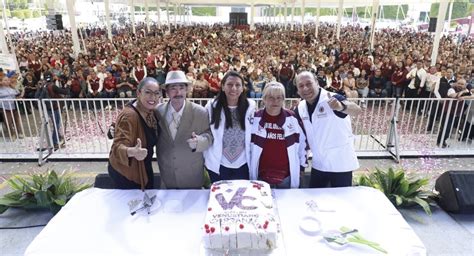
left=0, top=24, right=474, bottom=149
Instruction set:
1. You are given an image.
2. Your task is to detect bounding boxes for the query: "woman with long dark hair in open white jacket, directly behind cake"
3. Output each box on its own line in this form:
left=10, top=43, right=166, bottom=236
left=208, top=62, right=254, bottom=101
left=204, top=71, right=256, bottom=182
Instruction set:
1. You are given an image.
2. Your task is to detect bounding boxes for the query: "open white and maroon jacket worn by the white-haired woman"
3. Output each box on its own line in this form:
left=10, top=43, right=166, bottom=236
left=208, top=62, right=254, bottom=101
left=249, top=109, right=308, bottom=188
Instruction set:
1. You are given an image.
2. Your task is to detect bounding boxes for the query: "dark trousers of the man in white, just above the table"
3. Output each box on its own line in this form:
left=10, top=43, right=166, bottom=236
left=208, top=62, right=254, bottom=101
left=309, top=169, right=352, bottom=188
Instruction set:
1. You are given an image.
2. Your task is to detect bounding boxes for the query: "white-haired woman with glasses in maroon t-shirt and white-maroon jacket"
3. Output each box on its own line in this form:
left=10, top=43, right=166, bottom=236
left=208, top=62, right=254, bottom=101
left=250, top=82, right=307, bottom=188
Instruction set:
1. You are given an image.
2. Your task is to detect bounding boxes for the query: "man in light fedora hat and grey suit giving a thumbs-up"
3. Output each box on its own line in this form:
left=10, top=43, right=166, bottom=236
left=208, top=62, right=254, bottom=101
left=156, top=71, right=213, bottom=189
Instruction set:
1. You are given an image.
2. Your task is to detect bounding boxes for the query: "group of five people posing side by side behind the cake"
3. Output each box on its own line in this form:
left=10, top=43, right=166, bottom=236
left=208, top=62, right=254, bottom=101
left=108, top=70, right=361, bottom=189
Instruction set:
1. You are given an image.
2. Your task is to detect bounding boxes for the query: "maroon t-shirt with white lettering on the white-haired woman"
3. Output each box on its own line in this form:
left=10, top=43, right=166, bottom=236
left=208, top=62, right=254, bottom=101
left=259, top=111, right=290, bottom=184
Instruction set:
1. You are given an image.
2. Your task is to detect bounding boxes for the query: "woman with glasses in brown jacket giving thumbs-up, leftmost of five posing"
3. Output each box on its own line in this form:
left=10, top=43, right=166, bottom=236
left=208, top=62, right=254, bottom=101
left=108, top=77, right=161, bottom=190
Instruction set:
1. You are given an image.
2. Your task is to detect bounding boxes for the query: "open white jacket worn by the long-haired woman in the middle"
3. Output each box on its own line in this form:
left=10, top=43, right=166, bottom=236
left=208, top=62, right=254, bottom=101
left=204, top=99, right=257, bottom=174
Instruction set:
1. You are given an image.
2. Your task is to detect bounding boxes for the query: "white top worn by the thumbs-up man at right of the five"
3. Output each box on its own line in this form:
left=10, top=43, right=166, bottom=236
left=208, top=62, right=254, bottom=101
left=298, top=88, right=359, bottom=172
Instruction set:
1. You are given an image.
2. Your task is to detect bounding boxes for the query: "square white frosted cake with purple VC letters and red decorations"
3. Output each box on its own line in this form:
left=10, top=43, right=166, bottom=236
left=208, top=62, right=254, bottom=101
left=203, top=180, right=280, bottom=250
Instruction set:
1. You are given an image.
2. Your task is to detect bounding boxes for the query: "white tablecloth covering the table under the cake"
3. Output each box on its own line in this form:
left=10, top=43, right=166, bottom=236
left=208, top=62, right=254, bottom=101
left=25, top=187, right=426, bottom=256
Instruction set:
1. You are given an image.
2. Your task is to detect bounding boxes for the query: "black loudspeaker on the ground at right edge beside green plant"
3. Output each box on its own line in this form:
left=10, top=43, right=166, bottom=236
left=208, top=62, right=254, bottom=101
left=435, top=171, right=474, bottom=213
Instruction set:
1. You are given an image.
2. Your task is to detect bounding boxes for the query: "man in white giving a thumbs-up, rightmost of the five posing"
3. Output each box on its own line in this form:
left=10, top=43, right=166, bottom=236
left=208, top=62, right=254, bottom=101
left=295, top=71, right=362, bottom=188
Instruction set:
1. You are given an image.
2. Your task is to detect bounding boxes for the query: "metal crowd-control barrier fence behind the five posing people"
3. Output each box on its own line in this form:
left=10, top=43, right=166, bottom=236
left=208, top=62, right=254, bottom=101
left=0, top=98, right=474, bottom=164
